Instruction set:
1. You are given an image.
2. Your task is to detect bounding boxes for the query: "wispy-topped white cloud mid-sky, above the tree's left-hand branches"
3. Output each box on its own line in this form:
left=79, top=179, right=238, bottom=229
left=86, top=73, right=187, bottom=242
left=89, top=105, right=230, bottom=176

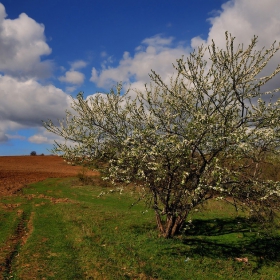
left=90, top=35, right=189, bottom=87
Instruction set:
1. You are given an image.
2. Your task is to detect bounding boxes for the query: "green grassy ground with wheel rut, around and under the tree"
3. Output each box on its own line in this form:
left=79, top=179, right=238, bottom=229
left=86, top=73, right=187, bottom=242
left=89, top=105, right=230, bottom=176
left=0, top=179, right=280, bottom=280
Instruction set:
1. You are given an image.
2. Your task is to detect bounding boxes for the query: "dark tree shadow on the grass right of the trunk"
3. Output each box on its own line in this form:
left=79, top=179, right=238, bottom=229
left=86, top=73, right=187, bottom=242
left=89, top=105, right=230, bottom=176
left=177, top=217, right=280, bottom=269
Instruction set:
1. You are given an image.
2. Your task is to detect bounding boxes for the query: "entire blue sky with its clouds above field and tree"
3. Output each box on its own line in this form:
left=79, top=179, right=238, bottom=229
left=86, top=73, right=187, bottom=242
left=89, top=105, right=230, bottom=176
left=0, top=0, right=280, bottom=155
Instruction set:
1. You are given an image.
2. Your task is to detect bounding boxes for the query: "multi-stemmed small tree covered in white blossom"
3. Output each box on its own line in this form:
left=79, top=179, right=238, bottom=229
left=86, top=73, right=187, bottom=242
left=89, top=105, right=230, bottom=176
left=44, top=33, right=280, bottom=238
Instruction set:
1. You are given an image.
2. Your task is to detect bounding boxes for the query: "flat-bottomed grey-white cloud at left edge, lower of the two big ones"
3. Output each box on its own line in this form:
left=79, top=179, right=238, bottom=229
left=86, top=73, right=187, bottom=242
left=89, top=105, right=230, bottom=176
left=0, top=75, right=70, bottom=130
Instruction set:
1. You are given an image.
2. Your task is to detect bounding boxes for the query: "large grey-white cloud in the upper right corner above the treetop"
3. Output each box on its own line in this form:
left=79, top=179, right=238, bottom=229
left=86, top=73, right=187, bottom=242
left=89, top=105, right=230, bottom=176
left=191, top=0, right=280, bottom=91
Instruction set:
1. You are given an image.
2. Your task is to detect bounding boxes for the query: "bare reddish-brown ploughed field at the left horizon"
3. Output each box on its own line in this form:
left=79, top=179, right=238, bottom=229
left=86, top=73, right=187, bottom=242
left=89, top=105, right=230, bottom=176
left=0, top=156, right=97, bottom=197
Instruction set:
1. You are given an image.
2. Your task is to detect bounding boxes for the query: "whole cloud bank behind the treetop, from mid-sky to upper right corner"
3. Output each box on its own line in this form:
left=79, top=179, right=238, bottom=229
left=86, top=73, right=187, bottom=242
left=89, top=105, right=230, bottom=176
left=90, top=0, right=280, bottom=93
